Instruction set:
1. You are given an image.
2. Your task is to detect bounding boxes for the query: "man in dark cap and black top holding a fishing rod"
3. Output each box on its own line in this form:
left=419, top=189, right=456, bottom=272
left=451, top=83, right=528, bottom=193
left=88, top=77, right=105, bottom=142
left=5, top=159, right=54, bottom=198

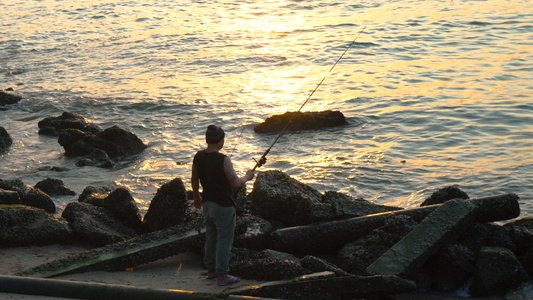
left=191, top=125, right=254, bottom=286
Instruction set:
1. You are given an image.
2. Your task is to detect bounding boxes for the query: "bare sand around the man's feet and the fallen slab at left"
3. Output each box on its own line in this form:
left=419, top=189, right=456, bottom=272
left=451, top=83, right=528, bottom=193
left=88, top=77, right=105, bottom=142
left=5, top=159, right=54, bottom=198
left=0, top=245, right=259, bottom=300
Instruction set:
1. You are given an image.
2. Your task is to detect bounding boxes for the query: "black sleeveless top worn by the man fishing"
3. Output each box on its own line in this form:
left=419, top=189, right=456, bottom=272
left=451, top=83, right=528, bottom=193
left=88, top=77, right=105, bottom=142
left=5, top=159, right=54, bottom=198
left=193, top=150, right=234, bottom=207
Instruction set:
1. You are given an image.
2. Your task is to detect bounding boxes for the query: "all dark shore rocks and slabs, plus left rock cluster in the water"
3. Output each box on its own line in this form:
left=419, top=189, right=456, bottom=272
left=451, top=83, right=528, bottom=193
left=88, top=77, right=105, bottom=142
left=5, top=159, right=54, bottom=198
left=0, top=92, right=533, bottom=299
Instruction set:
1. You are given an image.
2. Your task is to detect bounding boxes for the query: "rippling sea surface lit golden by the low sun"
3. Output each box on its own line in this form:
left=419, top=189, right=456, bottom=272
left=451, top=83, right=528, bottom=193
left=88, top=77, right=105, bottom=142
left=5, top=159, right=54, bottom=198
left=0, top=0, right=533, bottom=216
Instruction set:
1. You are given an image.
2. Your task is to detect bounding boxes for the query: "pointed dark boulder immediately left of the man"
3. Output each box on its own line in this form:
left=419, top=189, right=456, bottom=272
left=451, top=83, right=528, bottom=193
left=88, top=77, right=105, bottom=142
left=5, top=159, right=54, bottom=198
left=143, top=178, right=188, bottom=231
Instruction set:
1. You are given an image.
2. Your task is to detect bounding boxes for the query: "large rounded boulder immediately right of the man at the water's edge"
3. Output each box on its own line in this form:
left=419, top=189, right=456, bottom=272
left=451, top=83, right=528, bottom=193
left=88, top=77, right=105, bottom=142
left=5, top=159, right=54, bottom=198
left=248, top=171, right=322, bottom=226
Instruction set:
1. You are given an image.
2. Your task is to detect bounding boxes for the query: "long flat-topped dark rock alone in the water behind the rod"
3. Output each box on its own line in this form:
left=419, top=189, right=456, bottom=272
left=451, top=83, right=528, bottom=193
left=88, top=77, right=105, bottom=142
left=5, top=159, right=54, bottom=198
left=254, top=110, right=347, bottom=133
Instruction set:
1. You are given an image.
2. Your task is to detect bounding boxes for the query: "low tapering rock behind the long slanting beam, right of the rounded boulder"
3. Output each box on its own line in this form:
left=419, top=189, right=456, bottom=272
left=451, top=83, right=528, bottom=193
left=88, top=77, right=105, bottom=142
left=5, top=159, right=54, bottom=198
left=295, top=191, right=402, bottom=225
